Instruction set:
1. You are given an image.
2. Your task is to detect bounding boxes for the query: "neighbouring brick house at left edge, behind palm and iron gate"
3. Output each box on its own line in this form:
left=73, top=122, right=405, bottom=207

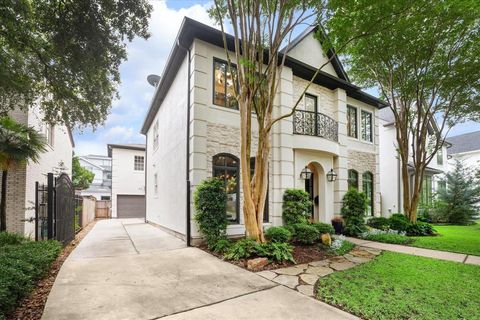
left=0, top=108, right=74, bottom=237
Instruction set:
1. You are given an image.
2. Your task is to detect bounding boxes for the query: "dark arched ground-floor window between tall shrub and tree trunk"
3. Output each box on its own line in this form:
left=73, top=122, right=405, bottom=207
left=213, top=153, right=240, bottom=223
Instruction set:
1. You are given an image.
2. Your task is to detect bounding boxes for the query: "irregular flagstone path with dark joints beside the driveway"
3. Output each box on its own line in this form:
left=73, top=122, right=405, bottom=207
left=257, top=247, right=382, bottom=297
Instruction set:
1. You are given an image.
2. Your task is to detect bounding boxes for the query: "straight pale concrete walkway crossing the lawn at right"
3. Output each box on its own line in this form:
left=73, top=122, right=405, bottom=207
left=346, top=237, right=480, bottom=265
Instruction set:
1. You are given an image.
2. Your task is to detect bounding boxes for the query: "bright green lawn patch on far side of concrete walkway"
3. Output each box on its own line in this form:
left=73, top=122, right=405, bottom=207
left=411, top=223, right=480, bottom=256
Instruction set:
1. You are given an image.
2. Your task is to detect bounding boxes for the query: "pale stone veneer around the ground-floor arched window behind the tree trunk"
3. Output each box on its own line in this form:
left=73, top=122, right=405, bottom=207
left=206, top=122, right=273, bottom=222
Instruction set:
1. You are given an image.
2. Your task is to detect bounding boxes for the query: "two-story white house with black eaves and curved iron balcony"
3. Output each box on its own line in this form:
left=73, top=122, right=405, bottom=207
left=139, top=18, right=385, bottom=240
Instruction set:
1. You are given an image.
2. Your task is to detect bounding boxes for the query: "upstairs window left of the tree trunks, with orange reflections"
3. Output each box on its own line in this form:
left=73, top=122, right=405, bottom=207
left=213, top=59, right=238, bottom=109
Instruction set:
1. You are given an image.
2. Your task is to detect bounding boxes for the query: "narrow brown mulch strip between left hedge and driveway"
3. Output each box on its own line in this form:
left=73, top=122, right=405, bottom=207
left=7, top=221, right=96, bottom=320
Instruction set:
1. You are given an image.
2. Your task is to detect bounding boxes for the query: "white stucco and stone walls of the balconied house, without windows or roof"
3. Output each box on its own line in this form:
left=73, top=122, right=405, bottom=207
left=142, top=17, right=380, bottom=241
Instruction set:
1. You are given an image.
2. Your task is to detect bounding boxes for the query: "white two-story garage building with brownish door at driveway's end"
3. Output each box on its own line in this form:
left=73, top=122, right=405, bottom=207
left=107, top=144, right=145, bottom=218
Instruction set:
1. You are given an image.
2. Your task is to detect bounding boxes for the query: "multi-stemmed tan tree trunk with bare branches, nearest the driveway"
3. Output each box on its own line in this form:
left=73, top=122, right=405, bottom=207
left=210, top=0, right=394, bottom=242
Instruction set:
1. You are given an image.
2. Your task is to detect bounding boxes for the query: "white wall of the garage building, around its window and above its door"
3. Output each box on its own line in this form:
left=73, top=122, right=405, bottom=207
left=108, top=144, right=145, bottom=218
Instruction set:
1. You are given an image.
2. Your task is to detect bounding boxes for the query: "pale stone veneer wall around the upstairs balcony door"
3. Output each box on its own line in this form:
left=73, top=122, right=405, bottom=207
left=293, top=76, right=337, bottom=119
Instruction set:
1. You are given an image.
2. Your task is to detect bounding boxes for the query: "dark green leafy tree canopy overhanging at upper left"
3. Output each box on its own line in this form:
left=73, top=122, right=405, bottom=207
left=0, top=0, right=152, bottom=127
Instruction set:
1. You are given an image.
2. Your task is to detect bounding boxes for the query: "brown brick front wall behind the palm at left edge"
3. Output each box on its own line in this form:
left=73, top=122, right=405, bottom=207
left=0, top=110, right=28, bottom=234
